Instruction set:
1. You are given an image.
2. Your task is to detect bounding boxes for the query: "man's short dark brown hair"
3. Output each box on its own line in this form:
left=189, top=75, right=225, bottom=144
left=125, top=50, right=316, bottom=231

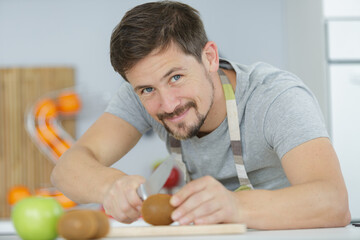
left=110, top=1, right=208, bottom=80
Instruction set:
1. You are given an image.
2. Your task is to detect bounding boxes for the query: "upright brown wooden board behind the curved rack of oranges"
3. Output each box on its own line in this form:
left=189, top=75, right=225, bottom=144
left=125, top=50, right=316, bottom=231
left=0, top=68, right=75, bottom=218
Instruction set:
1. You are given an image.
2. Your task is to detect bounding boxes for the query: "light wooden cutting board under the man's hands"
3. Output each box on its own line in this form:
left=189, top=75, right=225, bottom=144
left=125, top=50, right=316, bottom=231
left=106, top=224, right=246, bottom=237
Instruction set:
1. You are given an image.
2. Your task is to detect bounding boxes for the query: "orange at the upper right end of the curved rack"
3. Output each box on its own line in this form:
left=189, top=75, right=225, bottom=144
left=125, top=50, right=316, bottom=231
left=57, top=91, right=81, bottom=115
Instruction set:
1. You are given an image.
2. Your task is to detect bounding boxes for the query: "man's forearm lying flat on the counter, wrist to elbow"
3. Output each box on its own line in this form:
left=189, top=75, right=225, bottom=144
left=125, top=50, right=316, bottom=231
left=236, top=181, right=350, bottom=229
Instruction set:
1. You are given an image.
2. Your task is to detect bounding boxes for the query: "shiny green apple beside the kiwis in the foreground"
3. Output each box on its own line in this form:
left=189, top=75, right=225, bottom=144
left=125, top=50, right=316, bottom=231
left=11, top=197, right=64, bottom=240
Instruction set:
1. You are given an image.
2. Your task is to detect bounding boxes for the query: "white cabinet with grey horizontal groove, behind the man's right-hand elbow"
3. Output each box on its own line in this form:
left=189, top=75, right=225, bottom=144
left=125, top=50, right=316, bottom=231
left=327, top=18, right=360, bottom=220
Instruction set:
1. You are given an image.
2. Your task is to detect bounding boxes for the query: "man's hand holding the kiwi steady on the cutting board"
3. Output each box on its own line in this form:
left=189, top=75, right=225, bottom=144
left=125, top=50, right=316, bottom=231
left=170, top=176, right=241, bottom=225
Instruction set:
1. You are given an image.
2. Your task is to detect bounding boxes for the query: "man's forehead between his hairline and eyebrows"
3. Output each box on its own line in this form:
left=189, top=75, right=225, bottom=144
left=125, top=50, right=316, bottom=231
left=126, top=44, right=197, bottom=86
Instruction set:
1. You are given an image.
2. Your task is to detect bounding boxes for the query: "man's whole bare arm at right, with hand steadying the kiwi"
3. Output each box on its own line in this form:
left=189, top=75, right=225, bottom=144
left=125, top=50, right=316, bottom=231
left=171, top=138, right=350, bottom=229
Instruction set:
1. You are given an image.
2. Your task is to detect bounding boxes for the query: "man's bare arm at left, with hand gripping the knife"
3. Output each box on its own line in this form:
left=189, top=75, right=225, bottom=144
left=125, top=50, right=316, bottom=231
left=51, top=113, right=144, bottom=221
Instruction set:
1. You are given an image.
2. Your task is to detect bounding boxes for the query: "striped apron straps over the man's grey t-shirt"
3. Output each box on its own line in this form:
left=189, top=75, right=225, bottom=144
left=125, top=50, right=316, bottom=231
left=168, top=68, right=253, bottom=191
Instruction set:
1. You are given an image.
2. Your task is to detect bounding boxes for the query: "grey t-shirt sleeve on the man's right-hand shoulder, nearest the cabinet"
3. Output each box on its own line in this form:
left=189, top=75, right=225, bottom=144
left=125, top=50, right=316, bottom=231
left=263, top=86, right=329, bottom=159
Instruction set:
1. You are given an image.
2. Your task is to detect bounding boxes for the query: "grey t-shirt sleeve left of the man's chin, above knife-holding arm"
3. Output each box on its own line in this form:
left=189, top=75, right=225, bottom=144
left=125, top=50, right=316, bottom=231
left=105, top=83, right=151, bottom=134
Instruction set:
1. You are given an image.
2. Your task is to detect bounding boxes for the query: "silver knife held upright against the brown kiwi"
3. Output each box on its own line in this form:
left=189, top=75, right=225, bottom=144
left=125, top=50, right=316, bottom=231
left=137, top=155, right=174, bottom=201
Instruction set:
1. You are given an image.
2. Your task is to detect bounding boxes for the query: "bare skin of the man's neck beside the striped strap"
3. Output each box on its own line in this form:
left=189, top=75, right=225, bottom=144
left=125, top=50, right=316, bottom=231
left=197, top=69, right=236, bottom=137
